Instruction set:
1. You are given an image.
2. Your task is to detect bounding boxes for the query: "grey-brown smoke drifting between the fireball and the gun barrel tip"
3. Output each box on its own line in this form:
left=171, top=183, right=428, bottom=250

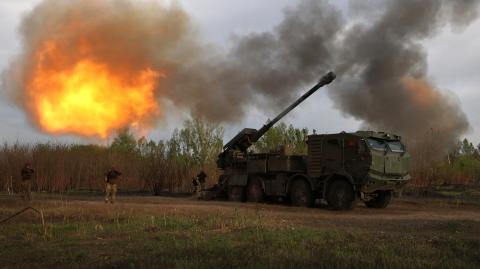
left=165, top=1, right=344, bottom=121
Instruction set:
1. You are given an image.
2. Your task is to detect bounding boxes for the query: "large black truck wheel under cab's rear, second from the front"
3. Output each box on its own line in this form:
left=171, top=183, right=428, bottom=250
left=326, top=180, right=355, bottom=210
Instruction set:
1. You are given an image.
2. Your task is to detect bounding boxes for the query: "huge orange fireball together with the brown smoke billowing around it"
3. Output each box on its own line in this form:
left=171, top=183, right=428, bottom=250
left=3, top=0, right=199, bottom=138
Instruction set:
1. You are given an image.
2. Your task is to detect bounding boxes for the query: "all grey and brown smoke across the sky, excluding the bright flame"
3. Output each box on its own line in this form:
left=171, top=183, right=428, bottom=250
left=3, top=0, right=478, bottom=151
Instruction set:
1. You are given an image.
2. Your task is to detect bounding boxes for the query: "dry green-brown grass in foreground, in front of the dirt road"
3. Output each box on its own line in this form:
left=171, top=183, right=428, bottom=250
left=0, top=196, right=480, bottom=268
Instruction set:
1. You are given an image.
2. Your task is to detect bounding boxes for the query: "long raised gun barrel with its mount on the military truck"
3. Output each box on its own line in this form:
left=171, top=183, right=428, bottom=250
left=217, top=72, right=336, bottom=169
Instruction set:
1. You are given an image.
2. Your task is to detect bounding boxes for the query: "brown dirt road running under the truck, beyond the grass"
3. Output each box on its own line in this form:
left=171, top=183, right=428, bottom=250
left=4, top=195, right=480, bottom=234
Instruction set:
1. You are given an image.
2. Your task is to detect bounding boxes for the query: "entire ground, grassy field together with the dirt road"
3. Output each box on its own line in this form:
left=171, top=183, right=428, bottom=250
left=0, top=194, right=480, bottom=268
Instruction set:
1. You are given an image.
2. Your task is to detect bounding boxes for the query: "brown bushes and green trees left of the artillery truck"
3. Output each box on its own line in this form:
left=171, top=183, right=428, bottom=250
left=0, top=118, right=224, bottom=194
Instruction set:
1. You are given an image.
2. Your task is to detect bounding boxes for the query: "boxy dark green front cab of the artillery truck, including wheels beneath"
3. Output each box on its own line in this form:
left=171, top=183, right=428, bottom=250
left=305, top=131, right=410, bottom=209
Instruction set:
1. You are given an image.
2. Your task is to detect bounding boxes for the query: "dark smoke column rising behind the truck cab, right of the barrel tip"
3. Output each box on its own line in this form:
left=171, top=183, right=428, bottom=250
left=330, top=0, right=479, bottom=151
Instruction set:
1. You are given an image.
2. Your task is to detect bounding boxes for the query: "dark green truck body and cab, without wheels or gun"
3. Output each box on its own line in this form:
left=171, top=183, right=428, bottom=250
left=225, top=132, right=410, bottom=206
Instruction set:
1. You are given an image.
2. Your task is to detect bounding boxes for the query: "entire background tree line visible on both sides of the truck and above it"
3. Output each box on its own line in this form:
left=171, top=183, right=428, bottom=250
left=0, top=118, right=480, bottom=194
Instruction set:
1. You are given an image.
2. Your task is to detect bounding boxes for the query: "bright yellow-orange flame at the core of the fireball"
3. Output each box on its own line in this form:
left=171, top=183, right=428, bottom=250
left=27, top=42, right=163, bottom=139
